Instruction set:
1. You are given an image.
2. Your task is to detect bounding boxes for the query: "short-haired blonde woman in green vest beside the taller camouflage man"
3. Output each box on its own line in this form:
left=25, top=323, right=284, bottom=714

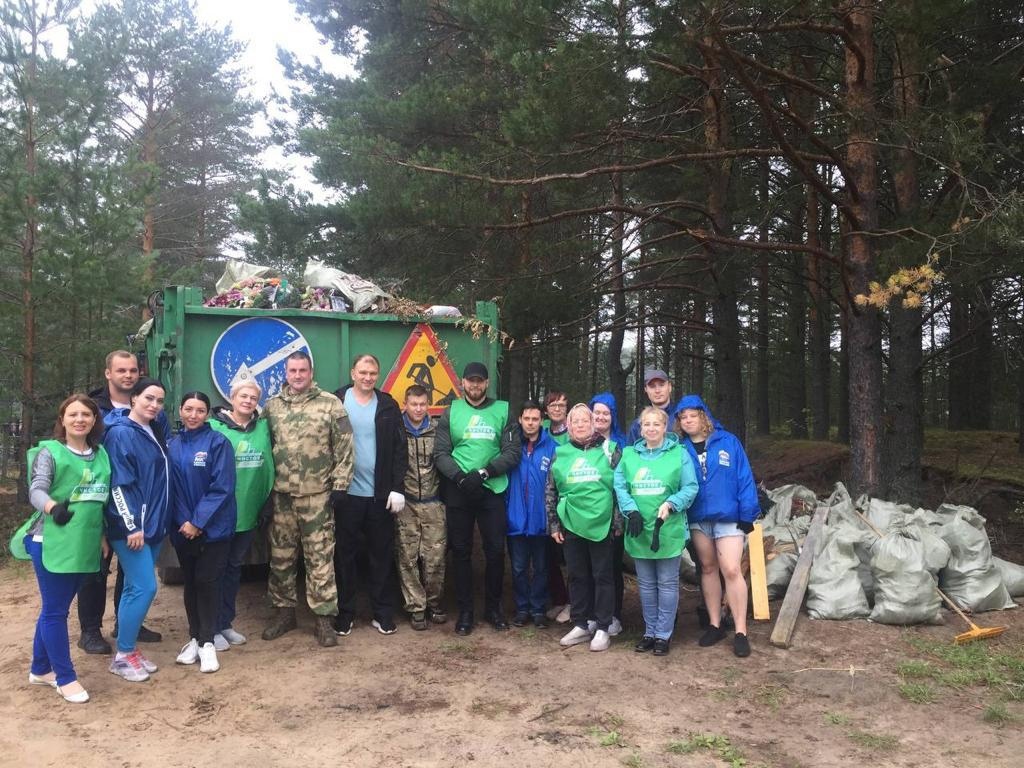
left=210, top=381, right=273, bottom=650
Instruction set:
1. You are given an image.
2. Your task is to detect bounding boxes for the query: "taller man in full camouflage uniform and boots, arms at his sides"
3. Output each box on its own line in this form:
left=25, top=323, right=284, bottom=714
left=263, top=351, right=352, bottom=646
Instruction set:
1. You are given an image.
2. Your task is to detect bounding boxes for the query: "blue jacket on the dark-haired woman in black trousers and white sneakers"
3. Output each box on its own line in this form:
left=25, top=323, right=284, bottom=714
left=169, top=423, right=239, bottom=544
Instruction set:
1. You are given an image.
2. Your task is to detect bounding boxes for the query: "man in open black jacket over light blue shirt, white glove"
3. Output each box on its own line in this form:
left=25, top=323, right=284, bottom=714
left=334, top=354, right=409, bottom=636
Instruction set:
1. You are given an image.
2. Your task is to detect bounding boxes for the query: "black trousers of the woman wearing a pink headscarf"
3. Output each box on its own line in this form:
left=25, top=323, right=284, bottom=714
left=563, top=530, right=615, bottom=630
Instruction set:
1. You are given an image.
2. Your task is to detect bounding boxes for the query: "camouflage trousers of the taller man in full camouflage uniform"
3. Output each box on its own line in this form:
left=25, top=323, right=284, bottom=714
left=267, top=492, right=338, bottom=616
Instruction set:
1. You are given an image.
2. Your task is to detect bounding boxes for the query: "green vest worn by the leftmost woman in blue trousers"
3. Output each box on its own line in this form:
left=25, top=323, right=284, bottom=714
left=10, top=440, right=111, bottom=573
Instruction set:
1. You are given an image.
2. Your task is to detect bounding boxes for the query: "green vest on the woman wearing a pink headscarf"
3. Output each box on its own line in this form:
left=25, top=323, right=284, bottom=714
left=551, top=440, right=614, bottom=542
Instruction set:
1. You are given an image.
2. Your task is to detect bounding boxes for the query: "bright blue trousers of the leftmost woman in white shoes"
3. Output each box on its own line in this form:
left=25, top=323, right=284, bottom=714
left=25, top=536, right=86, bottom=685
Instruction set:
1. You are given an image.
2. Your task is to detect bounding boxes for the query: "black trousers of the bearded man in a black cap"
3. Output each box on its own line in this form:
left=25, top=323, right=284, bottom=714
left=445, top=483, right=508, bottom=616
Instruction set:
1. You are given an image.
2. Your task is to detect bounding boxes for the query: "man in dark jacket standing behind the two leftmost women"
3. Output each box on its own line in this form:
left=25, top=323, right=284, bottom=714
left=78, top=349, right=170, bottom=655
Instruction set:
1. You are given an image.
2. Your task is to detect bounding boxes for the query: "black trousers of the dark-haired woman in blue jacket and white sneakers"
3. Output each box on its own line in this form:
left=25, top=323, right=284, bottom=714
left=174, top=537, right=231, bottom=645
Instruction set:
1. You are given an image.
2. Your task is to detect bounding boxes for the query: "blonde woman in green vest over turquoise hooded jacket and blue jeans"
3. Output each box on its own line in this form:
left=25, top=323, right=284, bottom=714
left=615, top=406, right=697, bottom=656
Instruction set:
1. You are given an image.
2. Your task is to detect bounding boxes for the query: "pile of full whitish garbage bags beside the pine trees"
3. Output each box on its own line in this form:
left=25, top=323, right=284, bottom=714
left=762, top=483, right=1024, bottom=625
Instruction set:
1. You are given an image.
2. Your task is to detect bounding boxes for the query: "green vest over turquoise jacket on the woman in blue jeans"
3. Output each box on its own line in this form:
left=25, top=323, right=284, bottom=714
left=618, top=442, right=688, bottom=560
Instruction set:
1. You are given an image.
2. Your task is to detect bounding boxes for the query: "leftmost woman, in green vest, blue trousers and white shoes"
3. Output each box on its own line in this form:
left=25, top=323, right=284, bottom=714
left=15, top=394, right=111, bottom=703
